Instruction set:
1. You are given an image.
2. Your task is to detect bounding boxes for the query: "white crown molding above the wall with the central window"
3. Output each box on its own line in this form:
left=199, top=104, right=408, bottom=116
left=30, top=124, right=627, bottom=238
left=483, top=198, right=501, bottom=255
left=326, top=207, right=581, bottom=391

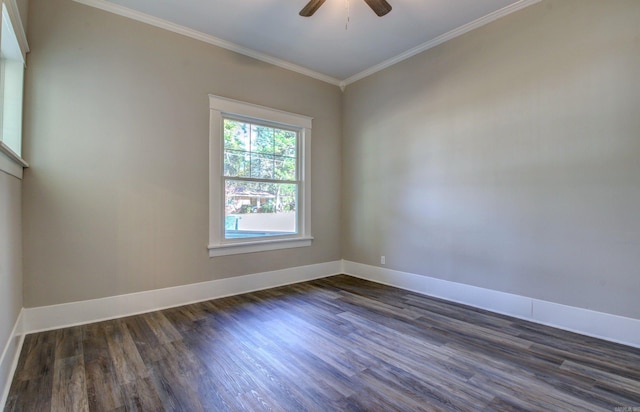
left=73, top=0, right=340, bottom=86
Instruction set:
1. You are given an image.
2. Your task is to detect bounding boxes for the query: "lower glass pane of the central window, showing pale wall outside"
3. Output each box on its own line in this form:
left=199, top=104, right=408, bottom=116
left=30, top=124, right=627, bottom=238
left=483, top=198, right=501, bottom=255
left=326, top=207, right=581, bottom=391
left=225, top=180, right=298, bottom=239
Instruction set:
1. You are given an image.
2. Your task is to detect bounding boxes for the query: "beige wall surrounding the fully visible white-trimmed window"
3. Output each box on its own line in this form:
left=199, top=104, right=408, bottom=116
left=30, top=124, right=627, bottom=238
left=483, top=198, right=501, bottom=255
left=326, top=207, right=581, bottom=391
left=24, top=0, right=342, bottom=307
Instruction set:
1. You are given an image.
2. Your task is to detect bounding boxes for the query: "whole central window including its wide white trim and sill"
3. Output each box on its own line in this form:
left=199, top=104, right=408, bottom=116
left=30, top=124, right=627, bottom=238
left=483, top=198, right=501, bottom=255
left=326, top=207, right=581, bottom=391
left=209, top=96, right=313, bottom=257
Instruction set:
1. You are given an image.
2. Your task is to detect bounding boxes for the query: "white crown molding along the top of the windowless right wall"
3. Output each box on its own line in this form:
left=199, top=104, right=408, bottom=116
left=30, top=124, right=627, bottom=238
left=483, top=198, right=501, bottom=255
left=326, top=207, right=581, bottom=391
left=339, top=0, right=542, bottom=86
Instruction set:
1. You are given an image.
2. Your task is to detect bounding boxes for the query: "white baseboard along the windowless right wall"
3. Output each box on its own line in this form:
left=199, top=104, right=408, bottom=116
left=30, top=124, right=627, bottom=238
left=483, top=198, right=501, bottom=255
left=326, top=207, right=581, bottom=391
left=342, top=260, right=640, bottom=348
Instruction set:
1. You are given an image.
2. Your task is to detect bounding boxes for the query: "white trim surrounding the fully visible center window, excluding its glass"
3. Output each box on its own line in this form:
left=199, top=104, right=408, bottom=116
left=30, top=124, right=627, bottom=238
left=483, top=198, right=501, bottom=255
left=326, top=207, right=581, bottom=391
left=209, top=95, right=313, bottom=257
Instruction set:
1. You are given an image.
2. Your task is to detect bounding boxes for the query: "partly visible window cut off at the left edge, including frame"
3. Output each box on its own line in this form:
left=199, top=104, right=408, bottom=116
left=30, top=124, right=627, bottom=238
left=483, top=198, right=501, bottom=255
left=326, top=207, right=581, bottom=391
left=0, top=0, right=29, bottom=177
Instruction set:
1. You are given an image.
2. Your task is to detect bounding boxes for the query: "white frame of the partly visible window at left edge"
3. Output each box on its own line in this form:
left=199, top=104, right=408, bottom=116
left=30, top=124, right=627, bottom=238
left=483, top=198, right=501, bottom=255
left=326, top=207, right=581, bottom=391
left=0, top=0, right=29, bottom=179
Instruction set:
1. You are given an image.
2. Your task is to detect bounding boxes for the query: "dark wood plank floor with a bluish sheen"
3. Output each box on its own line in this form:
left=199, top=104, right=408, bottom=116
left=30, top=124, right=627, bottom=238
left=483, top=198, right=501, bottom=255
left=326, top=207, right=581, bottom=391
left=5, top=276, right=640, bottom=411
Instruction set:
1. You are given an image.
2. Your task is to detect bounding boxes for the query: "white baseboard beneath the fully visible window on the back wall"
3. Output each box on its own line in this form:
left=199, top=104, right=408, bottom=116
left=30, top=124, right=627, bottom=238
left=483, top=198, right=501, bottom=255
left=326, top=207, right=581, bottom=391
left=23, top=261, right=342, bottom=333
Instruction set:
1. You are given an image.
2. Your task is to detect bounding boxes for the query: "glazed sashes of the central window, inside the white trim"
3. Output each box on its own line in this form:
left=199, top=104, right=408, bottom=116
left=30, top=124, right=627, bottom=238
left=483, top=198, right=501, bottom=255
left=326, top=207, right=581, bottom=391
left=223, top=116, right=300, bottom=239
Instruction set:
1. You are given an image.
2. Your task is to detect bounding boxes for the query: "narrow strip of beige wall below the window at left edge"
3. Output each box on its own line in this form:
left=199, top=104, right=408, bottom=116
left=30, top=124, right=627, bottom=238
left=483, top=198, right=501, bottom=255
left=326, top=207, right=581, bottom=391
left=0, top=171, right=22, bottom=358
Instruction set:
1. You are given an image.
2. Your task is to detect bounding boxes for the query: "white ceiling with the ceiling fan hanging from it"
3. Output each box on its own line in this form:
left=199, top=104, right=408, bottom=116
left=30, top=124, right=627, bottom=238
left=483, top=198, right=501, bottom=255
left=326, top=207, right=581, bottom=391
left=76, top=0, right=540, bottom=86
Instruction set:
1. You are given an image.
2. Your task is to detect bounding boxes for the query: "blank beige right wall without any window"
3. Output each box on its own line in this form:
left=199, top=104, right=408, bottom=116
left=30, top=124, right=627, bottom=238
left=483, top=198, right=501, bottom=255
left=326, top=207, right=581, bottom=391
left=343, top=0, right=640, bottom=318
